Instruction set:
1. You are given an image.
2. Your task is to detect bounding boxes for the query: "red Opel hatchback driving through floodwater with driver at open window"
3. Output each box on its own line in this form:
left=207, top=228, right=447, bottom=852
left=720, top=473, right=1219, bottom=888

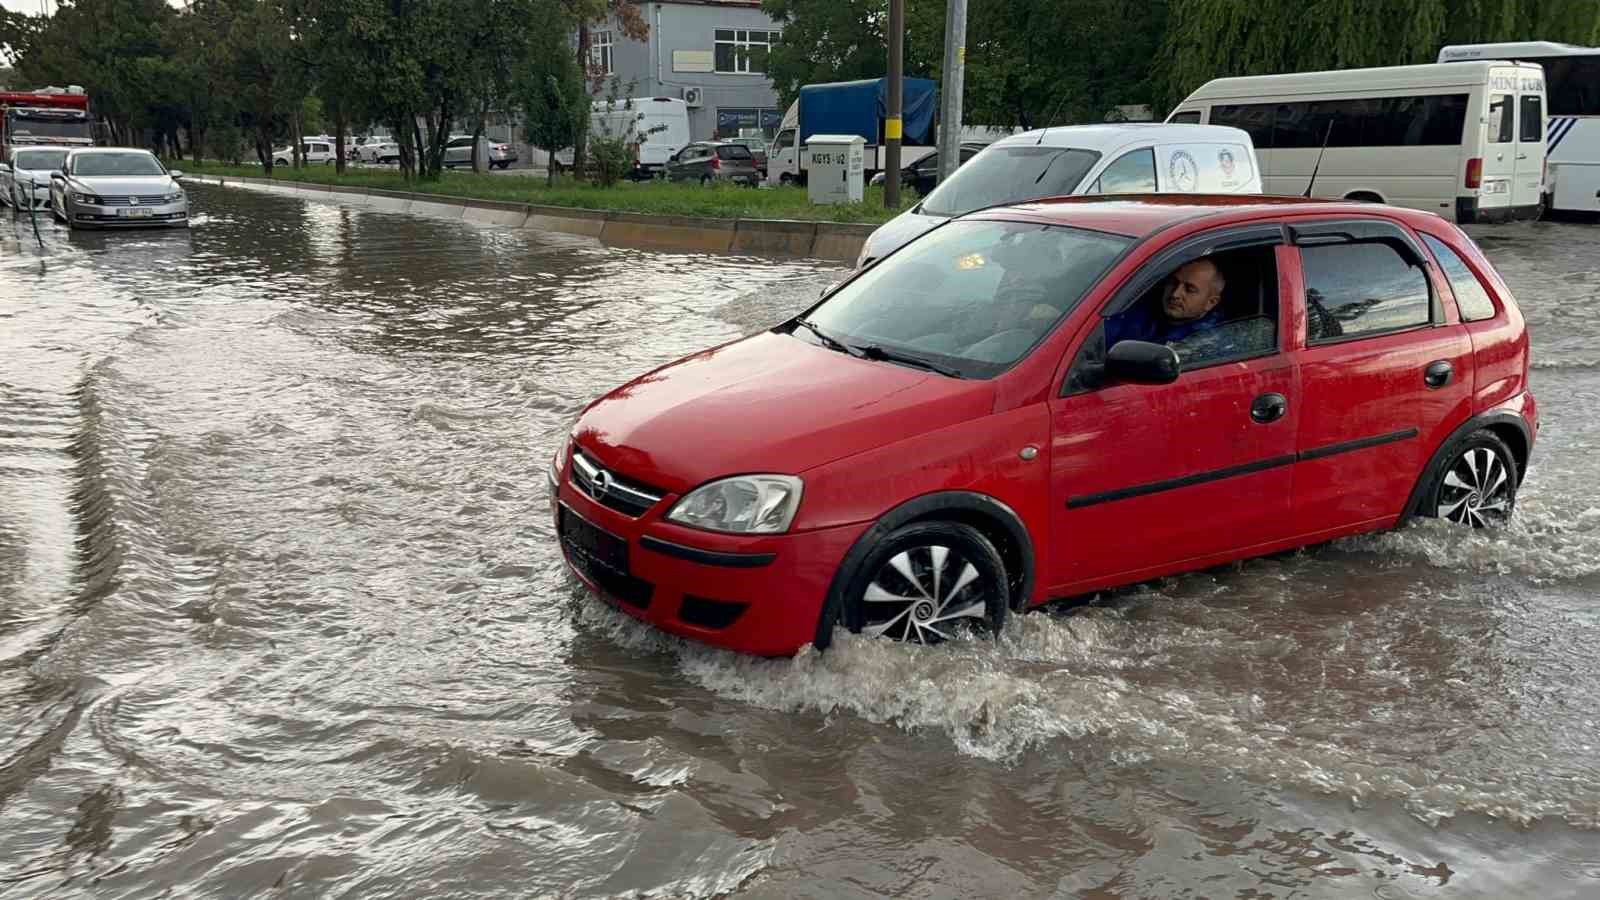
left=549, top=197, right=1538, bottom=655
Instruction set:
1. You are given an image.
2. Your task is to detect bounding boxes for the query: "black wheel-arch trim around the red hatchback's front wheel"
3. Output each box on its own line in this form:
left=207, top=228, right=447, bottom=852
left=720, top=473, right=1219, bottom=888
left=816, top=490, right=1035, bottom=649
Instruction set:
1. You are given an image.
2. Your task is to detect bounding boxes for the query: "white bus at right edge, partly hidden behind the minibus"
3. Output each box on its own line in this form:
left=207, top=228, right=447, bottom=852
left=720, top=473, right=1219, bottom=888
left=1438, top=40, right=1600, bottom=213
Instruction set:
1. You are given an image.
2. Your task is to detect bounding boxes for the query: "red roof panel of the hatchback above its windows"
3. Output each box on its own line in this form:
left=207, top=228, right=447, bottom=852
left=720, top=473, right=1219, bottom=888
left=963, top=194, right=1438, bottom=237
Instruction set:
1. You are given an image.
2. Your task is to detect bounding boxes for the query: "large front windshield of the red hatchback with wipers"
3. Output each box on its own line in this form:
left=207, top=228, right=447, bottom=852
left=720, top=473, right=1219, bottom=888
left=795, top=219, right=1133, bottom=378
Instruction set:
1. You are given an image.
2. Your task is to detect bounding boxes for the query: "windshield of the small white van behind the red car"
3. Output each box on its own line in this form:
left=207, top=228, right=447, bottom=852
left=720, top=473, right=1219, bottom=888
left=922, top=146, right=1099, bottom=216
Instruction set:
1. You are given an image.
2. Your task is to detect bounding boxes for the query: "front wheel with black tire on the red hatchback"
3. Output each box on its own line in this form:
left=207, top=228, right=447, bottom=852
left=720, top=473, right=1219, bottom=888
left=819, top=520, right=1010, bottom=644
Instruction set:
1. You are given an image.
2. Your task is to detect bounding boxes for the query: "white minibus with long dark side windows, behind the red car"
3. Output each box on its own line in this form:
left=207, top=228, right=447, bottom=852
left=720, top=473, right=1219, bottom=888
left=1166, top=61, right=1546, bottom=223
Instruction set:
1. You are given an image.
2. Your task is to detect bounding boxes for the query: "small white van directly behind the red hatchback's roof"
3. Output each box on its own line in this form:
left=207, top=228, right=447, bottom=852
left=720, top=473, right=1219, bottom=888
left=856, top=123, right=1261, bottom=267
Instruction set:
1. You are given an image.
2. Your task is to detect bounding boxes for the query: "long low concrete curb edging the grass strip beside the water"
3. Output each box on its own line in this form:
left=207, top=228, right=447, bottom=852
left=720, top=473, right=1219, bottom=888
left=193, top=175, right=878, bottom=263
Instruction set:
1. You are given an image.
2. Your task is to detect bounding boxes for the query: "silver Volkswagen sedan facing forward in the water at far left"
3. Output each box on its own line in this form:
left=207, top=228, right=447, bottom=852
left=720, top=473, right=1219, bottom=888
left=50, top=147, right=189, bottom=227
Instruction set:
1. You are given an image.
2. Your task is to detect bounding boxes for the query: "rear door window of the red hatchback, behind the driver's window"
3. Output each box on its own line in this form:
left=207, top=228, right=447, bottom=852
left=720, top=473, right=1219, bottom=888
left=1301, top=242, right=1432, bottom=344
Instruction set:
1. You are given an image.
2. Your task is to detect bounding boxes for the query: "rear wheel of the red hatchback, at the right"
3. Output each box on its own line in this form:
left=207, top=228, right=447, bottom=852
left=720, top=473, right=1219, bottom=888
left=1422, top=428, right=1522, bottom=528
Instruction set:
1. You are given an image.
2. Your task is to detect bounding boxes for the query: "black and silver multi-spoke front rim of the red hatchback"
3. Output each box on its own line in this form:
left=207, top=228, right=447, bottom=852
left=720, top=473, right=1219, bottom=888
left=861, top=544, right=1000, bottom=644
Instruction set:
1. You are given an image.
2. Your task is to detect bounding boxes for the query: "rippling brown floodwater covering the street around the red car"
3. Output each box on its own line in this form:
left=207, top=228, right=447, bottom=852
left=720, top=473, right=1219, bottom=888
left=0, top=187, right=1600, bottom=898
